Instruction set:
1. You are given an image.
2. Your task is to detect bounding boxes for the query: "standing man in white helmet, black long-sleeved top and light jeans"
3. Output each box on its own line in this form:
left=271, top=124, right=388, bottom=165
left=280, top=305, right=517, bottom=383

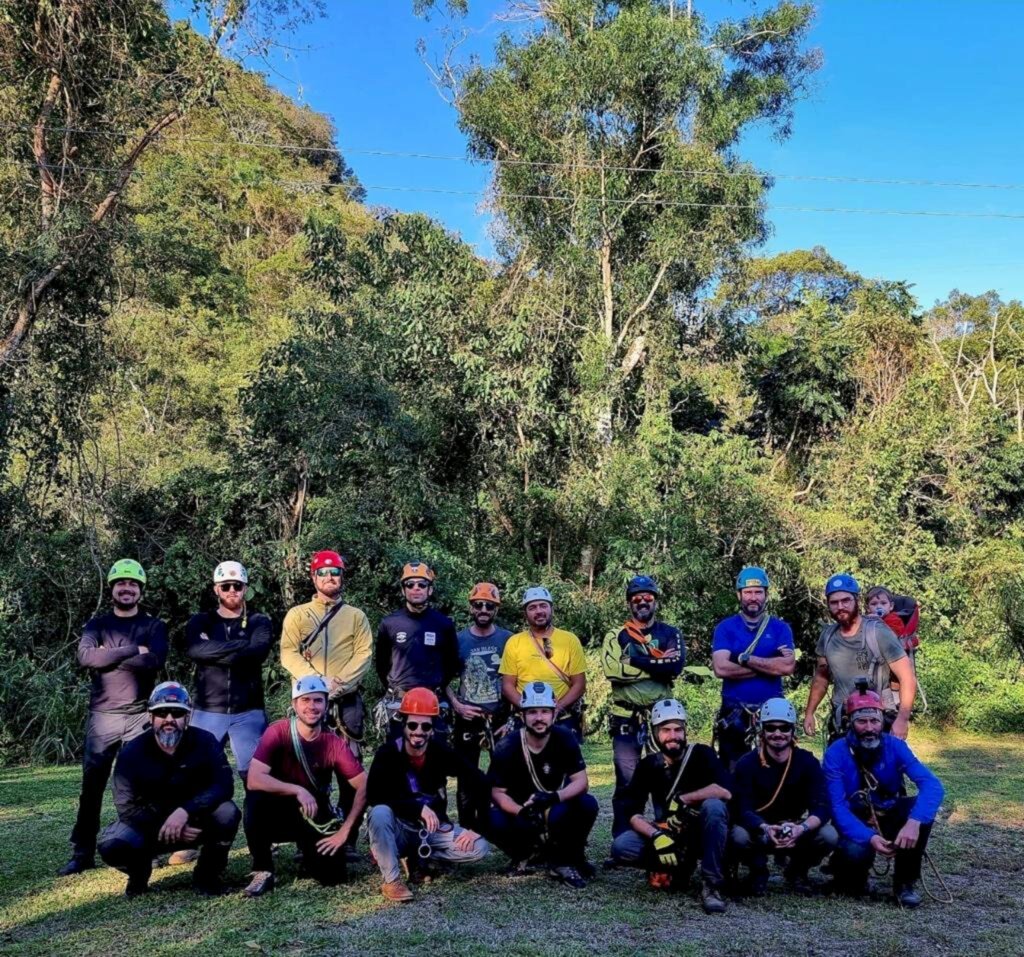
left=185, top=562, right=271, bottom=785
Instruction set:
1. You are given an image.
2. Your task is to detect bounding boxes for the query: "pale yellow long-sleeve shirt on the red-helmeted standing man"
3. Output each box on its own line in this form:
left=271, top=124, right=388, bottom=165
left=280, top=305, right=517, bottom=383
left=281, top=595, right=373, bottom=696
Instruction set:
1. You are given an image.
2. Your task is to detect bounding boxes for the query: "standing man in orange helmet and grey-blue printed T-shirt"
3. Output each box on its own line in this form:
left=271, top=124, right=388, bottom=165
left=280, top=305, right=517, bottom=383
left=446, top=581, right=512, bottom=827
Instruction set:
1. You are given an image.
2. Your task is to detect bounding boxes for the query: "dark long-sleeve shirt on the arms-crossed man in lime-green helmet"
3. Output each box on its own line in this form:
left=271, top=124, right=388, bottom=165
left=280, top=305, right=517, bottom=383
left=78, top=611, right=167, bottom=714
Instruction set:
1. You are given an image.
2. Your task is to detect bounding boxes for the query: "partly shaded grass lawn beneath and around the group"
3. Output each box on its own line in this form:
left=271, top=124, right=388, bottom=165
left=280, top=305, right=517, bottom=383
left=0, top=729, right=1024, bottom=957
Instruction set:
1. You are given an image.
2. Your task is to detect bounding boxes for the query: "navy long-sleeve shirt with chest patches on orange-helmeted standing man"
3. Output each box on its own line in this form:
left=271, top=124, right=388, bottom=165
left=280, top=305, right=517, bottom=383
left=374, top=608, right=462, bottom=692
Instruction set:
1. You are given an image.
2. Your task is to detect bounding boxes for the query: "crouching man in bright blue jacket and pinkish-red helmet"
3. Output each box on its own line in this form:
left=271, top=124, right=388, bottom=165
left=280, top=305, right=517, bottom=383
left=824, top=690, right=943, bottom=908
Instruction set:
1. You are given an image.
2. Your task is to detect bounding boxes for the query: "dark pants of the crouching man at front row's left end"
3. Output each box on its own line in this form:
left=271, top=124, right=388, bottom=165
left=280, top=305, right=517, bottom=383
left=99, top=800, right=242, bottom=882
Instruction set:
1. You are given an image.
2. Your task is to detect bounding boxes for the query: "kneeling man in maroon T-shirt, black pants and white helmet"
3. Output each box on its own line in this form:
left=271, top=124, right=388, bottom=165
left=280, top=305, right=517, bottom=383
left=244, top=675, right=367, bottom=898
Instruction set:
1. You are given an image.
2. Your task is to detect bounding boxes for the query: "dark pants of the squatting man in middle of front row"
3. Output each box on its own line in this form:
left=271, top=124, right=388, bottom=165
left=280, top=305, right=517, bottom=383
left=486, top=794, right=597, bottom=867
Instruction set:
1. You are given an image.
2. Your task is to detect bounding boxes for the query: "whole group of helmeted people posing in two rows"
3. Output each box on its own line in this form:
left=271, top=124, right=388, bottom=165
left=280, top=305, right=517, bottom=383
left=60, top=551, right=943, bottom=913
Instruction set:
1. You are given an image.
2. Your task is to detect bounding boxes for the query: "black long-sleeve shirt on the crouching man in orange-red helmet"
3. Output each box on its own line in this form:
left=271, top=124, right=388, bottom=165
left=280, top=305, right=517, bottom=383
left=367, top=738, right=490, bottom=827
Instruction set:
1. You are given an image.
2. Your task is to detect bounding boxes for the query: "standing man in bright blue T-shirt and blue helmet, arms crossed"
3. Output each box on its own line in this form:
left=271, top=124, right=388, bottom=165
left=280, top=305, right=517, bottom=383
left=711, top=565, right=797, bottom=771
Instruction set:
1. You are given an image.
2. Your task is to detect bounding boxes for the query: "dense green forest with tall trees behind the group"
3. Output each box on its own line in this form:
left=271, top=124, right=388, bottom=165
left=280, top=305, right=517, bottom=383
left=0, top=0, right=1024, bottom=762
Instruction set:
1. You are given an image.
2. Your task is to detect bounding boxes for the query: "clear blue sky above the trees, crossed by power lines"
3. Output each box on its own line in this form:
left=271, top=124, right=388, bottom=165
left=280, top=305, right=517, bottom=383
left=249, top=0, right=1024, bottom=307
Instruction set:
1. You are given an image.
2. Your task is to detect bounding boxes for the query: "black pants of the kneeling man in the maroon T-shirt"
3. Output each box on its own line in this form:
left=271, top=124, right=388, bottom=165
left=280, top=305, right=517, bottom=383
left=245, top=791, right=346, bottom=884
